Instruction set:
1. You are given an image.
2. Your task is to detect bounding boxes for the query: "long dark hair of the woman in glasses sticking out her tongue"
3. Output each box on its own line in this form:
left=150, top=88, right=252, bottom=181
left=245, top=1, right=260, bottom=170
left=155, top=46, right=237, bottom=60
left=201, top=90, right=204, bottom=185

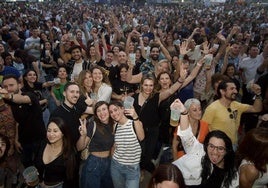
left=201, top=130, right=236, bottom=188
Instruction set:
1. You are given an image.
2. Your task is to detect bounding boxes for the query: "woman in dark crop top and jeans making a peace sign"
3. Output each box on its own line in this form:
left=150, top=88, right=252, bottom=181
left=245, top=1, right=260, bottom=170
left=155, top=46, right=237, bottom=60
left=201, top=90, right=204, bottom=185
left=76, top=101, right=114, bottom=188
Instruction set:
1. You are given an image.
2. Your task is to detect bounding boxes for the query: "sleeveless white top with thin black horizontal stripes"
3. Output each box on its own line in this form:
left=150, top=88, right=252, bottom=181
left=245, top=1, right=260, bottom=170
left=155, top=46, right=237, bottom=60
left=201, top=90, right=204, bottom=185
left=113, top=120, right=141, bottom=165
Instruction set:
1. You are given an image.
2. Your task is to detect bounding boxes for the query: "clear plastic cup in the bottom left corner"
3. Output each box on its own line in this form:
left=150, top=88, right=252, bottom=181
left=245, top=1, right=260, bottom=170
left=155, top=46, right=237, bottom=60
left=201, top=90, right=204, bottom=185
left=22, top=166, right=39, bottom=187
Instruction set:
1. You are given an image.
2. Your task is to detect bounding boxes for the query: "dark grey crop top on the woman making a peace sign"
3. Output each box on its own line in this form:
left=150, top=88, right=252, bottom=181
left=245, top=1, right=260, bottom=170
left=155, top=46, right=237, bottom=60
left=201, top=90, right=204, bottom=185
left=88, top=124, right=114, bottom=152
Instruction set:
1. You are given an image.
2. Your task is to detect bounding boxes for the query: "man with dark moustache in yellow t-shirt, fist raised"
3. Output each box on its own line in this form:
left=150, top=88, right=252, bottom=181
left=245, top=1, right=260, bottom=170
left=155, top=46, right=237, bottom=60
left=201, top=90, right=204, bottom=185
left=202, top=80, right=262, bottom=150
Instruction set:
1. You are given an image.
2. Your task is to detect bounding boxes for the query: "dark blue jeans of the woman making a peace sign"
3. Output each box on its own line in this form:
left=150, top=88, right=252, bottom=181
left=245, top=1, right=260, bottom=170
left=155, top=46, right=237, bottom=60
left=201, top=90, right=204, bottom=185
left=80, top=155, right=113, bottom=188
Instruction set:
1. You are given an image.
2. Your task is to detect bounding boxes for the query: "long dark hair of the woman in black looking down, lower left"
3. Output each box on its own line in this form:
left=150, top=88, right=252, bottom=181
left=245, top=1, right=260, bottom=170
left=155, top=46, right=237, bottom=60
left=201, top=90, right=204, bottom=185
left=48, top=117, right=77, bottom=180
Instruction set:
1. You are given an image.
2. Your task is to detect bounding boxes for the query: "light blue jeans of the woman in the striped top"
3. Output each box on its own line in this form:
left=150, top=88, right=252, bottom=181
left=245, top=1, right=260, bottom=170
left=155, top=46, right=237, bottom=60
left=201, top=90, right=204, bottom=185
left=111, top=159, right=140, bottom=188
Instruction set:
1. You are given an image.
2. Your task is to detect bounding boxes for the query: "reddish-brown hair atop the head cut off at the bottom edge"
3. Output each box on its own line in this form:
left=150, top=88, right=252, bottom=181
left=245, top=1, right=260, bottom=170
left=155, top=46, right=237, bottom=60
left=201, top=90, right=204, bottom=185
left=148, top=164, right=186, bottom=188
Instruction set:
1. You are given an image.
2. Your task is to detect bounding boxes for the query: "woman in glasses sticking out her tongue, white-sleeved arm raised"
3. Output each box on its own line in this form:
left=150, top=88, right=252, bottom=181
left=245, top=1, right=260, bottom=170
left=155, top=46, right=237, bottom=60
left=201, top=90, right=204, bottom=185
left=172, top=99, right=239, bottom=188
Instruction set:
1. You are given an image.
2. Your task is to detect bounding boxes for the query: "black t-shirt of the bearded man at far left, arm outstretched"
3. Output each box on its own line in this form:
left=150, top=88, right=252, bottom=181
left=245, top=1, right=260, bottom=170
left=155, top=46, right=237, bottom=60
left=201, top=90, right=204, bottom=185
left=7, top=92, right=46, bottom=144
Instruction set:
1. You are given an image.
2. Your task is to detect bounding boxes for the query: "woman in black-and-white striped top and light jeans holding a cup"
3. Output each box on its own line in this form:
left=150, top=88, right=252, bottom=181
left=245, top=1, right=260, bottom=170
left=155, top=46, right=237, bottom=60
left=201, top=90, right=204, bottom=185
left=109, top=101, right=144, bottom=188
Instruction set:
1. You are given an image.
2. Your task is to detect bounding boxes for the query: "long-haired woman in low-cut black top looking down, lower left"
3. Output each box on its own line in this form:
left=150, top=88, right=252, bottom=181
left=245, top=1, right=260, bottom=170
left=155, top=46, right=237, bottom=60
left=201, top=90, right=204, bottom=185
left=35, top=118, right=76, bottom=188
